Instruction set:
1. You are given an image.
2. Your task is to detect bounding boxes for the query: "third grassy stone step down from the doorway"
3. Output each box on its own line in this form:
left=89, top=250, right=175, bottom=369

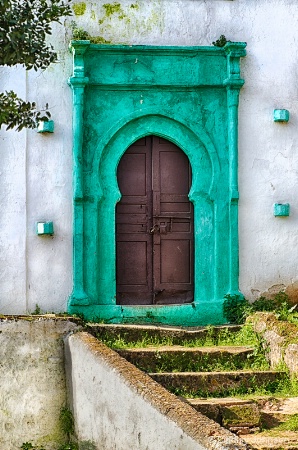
left=149, top=370, right=287, bottom=397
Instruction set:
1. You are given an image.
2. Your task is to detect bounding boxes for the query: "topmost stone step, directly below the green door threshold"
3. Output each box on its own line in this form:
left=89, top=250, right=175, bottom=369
left=86, top=323, right=241, bottom=345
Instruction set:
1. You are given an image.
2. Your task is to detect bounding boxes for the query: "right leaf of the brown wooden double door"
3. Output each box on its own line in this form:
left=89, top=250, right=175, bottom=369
left=152, top=136, right=193, bottom=303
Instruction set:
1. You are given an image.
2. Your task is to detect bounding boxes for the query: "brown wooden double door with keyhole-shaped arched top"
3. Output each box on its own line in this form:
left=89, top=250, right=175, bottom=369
left=116, top=136, right=193, bottom=305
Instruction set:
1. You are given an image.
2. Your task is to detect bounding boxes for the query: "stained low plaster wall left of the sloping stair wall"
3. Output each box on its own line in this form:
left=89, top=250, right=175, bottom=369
left=0, top=317, right=76, bottom=450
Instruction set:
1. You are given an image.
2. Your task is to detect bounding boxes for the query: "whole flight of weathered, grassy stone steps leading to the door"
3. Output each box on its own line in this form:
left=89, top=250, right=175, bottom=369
left=89, top=325, right=298, bottom=450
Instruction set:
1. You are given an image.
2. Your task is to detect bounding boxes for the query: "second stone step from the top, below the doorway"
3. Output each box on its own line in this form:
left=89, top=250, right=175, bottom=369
left=117, top=345, right=253, bottom=372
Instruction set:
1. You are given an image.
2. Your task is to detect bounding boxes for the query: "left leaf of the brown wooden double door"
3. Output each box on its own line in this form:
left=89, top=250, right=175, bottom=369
left=116, top=138, right=152, bottom=305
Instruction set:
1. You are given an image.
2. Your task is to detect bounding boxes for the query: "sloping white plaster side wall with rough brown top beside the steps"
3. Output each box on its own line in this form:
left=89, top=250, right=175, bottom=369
left=66, top=333, right=248, bottom=450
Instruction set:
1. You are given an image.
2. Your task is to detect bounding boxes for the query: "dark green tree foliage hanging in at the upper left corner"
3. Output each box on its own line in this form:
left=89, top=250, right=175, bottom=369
left=0, top=0, right=71, bottom=131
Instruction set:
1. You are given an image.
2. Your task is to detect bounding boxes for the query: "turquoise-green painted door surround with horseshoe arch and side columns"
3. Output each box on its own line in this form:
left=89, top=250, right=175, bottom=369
left=69, top=41, right=246, bottom=325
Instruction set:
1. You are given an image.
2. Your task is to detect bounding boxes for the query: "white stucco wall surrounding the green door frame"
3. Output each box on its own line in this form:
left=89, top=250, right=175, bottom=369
left=0, top=0, right=298, bottom=313
